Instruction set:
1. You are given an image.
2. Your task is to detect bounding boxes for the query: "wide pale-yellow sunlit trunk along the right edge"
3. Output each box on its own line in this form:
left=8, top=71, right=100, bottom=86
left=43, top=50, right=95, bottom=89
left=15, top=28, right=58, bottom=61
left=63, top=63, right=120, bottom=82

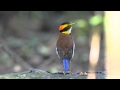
left=104, top=11, right=120, bottom=79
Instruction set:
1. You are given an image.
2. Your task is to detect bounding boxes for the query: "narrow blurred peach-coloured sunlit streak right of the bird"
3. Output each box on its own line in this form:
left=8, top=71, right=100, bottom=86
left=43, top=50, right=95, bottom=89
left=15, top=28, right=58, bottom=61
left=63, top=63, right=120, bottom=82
left=88, top=27, right=100, bottom=79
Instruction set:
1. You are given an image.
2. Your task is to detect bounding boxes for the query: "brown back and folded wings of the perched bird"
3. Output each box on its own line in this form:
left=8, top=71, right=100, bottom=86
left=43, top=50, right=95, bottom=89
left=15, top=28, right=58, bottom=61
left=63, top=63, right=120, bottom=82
left=56, top=33, right=74, bottom=60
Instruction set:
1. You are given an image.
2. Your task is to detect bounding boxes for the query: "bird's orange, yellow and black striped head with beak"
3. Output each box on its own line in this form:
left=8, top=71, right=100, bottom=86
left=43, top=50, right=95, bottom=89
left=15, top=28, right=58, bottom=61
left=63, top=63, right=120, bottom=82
left=59, top=22, right=76, bottom=34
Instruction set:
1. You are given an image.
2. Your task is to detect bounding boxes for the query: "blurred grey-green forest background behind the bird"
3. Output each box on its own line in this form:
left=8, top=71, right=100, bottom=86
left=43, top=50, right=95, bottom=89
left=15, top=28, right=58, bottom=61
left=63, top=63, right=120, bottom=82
left=0, top=11, right=105, bottom=74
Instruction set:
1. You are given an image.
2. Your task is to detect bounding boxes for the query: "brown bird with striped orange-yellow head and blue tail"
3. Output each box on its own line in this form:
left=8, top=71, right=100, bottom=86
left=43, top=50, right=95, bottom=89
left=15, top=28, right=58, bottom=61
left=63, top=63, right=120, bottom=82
left=56, top=22, right=76, bottom=74
